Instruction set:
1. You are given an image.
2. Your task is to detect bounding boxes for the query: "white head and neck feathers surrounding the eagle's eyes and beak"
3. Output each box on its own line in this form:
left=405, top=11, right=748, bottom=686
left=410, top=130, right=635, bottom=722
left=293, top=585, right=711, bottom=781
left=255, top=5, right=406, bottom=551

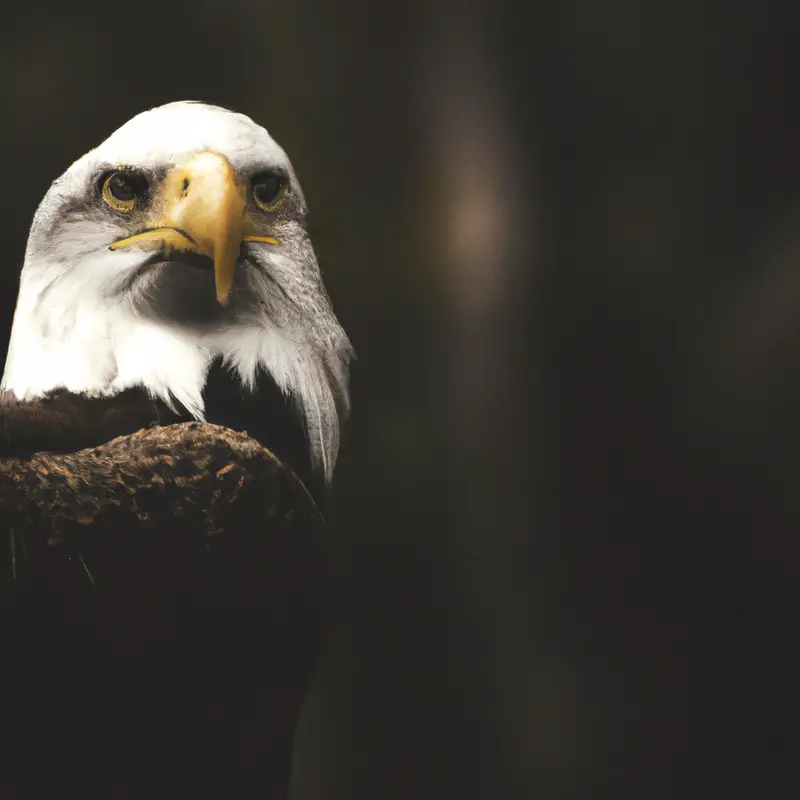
left=2, top=102, right=351, bottom=478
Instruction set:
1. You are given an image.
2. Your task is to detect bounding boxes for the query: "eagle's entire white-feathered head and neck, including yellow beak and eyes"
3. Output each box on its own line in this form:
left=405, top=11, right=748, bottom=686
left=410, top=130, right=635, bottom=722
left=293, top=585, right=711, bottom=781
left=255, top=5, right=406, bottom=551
left=2, top=102, right=352, bottom=479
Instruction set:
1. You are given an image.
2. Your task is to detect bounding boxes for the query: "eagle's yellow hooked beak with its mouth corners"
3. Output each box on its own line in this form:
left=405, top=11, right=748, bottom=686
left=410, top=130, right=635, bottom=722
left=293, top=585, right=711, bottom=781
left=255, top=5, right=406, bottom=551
left=111, top=152, right=278, bottom=306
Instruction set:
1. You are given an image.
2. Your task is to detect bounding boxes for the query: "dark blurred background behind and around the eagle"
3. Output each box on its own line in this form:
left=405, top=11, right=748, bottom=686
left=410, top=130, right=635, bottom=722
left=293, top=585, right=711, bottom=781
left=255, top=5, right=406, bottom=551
left=0, top=0, right=800, bottom=800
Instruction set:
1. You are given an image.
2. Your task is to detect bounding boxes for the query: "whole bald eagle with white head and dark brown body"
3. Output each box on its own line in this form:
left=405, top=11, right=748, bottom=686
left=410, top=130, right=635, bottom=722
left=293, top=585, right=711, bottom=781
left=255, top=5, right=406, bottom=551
left=0, top=102, right=352, bottom=797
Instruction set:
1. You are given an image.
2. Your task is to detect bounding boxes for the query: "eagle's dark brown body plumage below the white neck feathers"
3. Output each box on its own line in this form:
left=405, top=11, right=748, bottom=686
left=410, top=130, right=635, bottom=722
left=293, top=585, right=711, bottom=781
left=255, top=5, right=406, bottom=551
left=0, top=416, right=327, bottom=798
